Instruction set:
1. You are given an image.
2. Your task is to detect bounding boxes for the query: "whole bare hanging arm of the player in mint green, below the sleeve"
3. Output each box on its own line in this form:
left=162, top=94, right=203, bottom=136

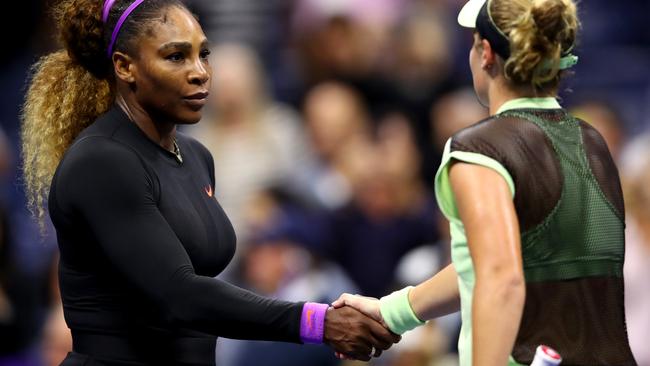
left=450, top=163, right=526, bottom=366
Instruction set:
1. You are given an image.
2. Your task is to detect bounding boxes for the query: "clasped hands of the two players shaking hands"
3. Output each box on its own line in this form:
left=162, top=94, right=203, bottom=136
left=323, top=294, right=402, bottom=361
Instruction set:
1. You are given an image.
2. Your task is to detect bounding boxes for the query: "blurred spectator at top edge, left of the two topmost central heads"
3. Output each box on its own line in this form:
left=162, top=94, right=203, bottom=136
left=292, top=0, right=394, bottom=86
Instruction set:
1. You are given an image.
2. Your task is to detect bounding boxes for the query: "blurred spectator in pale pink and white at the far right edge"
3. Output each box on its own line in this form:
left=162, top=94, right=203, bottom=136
left=620, top=134, right=650, bottom=366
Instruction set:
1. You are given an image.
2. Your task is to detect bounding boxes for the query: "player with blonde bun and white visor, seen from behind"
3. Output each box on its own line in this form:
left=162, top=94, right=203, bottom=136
left=334, top=0, right=636, bottom=366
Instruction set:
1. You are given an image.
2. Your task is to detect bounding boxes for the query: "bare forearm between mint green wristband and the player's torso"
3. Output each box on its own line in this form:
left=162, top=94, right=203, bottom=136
left=409, top=264, right=460, bottom=320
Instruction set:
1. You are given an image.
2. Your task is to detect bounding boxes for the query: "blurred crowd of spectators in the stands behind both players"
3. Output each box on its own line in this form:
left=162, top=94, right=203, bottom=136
left=0, top=0, right=650, bottom=366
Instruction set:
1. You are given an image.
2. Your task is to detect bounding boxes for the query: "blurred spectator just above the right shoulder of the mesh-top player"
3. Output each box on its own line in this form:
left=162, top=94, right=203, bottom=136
left=571, top=100, right=625, bottom=161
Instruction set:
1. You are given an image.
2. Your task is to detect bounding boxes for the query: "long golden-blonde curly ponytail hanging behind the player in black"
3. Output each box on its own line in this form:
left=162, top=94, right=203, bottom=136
left=22, top=51, right=113, bottom=223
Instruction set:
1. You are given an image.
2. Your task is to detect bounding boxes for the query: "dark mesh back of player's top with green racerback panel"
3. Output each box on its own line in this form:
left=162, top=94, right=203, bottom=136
left=451, top=109, right=636, bottom=365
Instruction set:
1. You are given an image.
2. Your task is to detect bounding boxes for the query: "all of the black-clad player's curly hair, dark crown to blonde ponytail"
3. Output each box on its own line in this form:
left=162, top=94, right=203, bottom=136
left=22, top=0, right=187, bottom=226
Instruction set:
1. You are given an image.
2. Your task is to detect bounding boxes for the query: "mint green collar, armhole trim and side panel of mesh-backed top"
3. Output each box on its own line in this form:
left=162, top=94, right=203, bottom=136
left=435, top=98, right=561, bottom=366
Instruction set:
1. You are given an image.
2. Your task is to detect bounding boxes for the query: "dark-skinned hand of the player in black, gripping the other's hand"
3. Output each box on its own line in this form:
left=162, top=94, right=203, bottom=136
left=324, top=306, right=401, bottom=361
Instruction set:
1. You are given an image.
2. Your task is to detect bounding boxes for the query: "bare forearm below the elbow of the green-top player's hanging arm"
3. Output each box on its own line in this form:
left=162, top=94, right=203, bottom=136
left=472, top=273, right=526, bottom=366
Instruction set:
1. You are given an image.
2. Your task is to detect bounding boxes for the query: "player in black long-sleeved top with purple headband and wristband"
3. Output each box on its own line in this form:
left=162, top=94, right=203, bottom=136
left=23, top=0, right=399, bottom=365
